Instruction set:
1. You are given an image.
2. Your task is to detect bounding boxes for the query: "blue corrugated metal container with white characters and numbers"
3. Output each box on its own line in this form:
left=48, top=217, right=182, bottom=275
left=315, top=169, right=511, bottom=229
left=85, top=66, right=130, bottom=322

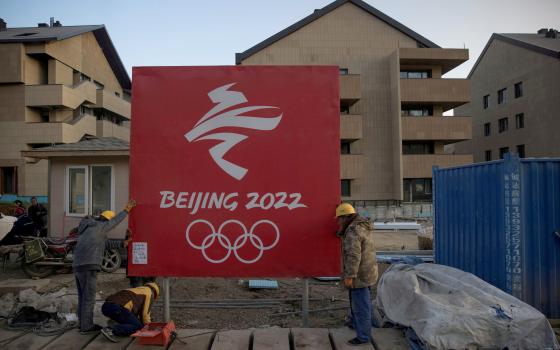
left=433, top=155, right=560, bottom=318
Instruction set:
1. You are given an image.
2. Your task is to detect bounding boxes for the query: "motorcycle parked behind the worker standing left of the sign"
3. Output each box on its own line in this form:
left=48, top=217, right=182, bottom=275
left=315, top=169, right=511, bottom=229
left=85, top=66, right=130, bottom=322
left=21, top=230, right=122, bottom=278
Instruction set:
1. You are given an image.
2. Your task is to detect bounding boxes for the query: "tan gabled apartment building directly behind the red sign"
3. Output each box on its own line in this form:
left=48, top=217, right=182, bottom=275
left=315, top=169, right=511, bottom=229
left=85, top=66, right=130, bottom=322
left=236, top=0, right=472, bottom=205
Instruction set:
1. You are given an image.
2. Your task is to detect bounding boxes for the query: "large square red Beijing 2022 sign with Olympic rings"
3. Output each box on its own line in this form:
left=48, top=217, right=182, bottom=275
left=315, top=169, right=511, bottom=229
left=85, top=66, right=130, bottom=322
left=129, top=66, right=340, bottom=277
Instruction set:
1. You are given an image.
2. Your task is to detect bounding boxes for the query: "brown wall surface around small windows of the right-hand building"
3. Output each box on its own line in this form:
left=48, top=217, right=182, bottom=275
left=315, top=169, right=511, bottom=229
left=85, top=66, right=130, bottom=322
left=454, top=39, right=560, bottom=162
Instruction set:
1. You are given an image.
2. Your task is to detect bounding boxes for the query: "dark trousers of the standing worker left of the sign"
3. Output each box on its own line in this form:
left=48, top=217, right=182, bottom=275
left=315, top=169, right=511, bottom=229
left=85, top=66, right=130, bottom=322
left=74, top=270, right=97, bottom=331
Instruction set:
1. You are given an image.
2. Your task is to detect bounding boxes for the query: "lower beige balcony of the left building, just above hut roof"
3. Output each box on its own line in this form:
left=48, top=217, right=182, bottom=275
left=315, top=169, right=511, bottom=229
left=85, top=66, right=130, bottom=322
left=21, top=114, right=96, bottom=144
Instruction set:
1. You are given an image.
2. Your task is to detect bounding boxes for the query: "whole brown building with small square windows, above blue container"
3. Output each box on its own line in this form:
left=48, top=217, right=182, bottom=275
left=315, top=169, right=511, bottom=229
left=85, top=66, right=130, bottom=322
left=454, top=29, right=560, bottom=162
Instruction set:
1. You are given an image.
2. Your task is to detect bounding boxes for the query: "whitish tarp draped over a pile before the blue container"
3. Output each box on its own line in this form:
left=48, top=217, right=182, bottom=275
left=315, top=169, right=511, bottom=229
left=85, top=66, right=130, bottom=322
left=376, top=264, right=560, bottom=350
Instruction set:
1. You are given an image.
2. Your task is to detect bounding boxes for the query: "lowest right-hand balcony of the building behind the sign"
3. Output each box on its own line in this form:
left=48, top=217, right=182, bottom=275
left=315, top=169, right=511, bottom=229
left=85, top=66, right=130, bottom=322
left=402, top=154, right=473, bottom=179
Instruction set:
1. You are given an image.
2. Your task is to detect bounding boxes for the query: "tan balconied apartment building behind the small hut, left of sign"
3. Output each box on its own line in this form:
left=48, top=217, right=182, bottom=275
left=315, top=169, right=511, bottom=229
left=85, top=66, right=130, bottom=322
left=0, top=19, right=131, bottom=195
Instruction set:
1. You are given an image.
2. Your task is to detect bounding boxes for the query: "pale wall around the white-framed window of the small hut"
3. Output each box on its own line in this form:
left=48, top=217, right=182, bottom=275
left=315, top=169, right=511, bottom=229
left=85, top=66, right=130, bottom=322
left=49, top=156, right=129, bottom=238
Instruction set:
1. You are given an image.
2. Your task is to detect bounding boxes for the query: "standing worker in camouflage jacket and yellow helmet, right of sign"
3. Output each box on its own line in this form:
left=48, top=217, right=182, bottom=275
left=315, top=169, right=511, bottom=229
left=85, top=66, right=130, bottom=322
left=336, top=203, right=377, bottom=345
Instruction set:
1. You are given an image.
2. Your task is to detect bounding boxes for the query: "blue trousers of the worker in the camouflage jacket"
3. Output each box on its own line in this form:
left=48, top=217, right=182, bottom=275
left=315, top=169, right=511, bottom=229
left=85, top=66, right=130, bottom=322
left=349, top=287, right=372, bottom=341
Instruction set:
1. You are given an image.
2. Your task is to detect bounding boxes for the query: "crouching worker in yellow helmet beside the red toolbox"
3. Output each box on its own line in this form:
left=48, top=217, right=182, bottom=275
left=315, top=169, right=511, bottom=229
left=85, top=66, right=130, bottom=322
left=101, top=278, right=159, bottom=343
